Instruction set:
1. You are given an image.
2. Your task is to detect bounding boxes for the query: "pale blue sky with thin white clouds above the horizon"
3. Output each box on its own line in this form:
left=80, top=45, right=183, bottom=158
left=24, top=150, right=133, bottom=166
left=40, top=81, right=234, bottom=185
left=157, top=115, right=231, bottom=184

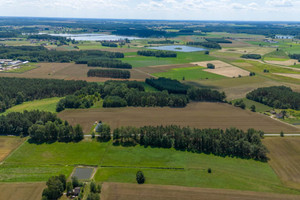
left=0, top=0, right=300, bottom=21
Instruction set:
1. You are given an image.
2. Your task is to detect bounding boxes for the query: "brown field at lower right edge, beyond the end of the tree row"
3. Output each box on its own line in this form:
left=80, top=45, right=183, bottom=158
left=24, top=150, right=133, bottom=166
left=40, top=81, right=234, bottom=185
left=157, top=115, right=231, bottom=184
left=263, top=137, right=300, bottom=189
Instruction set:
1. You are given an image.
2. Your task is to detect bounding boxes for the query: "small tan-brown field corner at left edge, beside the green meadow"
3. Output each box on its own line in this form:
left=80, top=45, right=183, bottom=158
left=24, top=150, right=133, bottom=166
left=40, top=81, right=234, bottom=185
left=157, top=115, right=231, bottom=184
left=0, top=136, right=25, bottom=162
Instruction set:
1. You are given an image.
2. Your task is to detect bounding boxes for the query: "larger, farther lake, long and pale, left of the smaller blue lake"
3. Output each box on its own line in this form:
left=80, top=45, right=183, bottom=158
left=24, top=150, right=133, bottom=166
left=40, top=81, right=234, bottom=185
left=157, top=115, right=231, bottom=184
left=49, top=33, right=140, bottom=41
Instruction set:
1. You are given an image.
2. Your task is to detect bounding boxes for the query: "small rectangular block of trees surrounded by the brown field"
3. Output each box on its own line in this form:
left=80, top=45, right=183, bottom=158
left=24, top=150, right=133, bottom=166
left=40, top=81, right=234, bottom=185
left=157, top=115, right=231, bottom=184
left=87, top=69, right=130, bottom=79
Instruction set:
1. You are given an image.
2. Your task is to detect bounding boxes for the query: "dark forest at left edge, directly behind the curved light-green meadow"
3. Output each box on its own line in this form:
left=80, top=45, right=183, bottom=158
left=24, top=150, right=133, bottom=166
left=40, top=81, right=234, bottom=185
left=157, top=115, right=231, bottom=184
left=0, top=77, right=87, bottom=112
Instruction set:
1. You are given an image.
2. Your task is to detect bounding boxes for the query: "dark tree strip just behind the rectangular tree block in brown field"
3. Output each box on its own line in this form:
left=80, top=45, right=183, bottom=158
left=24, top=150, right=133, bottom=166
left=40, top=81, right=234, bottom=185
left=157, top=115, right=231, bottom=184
left=87, top=59, right=132, bottom=69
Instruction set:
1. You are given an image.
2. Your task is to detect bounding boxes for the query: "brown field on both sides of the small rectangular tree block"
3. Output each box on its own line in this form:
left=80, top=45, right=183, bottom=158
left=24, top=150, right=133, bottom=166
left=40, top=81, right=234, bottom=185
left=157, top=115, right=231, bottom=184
left=0, top=63, right=150, bottom=82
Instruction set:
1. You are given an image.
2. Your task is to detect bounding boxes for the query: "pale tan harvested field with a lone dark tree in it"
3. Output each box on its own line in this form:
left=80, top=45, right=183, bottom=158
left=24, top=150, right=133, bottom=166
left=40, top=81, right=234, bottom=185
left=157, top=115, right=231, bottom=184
left=192, top=60, right=249, bottom=77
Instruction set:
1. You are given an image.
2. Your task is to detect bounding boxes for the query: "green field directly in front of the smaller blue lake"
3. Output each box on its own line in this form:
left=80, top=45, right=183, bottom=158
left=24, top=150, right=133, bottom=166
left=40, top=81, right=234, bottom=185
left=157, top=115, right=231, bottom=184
left=121, top=52, right=214, bottom=67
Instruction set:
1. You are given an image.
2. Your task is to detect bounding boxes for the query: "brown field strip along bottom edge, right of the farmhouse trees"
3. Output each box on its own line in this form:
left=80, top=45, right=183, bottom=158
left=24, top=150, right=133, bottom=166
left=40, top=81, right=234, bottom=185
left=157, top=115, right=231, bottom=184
left=101, top=183, right=300, bottom=200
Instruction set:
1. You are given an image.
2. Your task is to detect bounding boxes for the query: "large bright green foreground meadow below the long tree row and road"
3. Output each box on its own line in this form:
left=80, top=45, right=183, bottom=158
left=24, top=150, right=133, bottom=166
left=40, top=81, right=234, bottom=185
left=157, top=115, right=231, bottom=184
left=0, top=140, right=300, bottom=194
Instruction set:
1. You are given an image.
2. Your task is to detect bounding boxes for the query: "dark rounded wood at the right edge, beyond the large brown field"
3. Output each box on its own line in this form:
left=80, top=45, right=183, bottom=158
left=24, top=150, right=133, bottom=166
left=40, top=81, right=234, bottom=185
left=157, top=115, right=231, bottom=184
left=247, top=86, right=300, bottom=110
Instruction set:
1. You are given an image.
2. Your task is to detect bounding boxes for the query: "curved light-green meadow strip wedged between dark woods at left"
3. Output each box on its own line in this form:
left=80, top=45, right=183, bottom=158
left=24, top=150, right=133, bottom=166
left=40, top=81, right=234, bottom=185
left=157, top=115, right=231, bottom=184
left=2, top=97, right=62, bottom=115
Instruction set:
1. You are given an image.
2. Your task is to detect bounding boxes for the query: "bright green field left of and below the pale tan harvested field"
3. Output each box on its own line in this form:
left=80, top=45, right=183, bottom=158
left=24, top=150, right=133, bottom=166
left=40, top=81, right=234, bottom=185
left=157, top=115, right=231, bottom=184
left=153, top=67, right=225, bottom=81
